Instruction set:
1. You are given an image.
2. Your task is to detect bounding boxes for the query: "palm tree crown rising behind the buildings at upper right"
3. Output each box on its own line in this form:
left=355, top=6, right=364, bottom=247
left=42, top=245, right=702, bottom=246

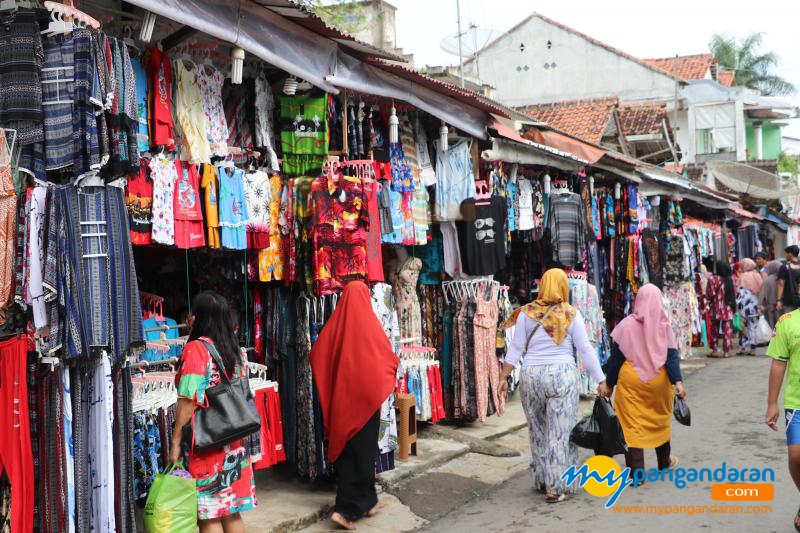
left=709, top=32, right=795, bottom=96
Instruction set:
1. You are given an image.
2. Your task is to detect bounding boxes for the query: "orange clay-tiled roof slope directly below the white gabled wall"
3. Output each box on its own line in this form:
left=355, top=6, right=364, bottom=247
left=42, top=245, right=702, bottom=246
left=519, top=97, right=619, bottom=144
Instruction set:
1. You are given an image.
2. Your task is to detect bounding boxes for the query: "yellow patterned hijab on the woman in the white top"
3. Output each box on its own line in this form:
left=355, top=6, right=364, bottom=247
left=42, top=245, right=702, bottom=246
left=502, top=268, right=576, bottom=344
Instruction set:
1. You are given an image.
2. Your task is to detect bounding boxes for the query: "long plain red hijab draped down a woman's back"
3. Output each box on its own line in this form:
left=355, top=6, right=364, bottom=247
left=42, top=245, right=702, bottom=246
left=311, top=281, right=399, bottom=462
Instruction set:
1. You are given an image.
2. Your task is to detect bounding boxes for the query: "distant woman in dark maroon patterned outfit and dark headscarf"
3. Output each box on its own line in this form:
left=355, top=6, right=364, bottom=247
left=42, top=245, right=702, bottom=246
left=706, top=261, right=736, bottom=357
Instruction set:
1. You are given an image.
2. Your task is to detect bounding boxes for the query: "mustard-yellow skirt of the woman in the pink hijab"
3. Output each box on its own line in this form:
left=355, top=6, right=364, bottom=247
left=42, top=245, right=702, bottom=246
left=614, top=361, right=674, bottom=448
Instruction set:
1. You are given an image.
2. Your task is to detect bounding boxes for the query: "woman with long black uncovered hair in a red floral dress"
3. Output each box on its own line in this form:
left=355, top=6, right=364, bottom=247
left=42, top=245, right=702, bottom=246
left=170, top=291, right=257, bottom=533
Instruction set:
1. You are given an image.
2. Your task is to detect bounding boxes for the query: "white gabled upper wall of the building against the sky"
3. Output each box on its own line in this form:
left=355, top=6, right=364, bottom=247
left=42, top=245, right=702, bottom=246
left=465, top=16, right=675, bottom=106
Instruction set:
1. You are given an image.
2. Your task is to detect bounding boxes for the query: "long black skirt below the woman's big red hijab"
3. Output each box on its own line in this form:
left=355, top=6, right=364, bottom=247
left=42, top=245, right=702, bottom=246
left=333, top=409, right=381, bottom=521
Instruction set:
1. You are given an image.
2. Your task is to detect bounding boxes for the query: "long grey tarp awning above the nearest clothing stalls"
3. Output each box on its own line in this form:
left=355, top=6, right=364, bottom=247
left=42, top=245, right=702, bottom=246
left=129, top=0, right=488, bottom=139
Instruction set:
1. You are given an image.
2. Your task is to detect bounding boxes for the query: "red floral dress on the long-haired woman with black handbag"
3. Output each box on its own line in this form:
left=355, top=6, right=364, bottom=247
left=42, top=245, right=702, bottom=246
left=175, top=338, right=258, bottom=520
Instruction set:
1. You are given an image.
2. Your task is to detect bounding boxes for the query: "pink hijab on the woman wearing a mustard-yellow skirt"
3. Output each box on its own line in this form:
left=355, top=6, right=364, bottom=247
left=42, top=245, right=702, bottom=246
left=611, top=283, right=678, bottom=383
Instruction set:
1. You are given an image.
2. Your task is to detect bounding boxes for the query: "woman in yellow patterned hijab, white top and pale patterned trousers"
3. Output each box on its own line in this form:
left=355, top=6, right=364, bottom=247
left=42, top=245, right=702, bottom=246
left=500, top=268, right=605, bottom=503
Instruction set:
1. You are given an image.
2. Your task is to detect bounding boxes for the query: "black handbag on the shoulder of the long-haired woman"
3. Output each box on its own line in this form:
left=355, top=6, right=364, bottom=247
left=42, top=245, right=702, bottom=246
left=183, top=340, right=261, bottom=452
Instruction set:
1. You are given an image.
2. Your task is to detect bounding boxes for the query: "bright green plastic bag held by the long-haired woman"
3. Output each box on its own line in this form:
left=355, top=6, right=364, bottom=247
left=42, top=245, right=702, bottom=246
left=144, top=462, right=197, bottom=533
